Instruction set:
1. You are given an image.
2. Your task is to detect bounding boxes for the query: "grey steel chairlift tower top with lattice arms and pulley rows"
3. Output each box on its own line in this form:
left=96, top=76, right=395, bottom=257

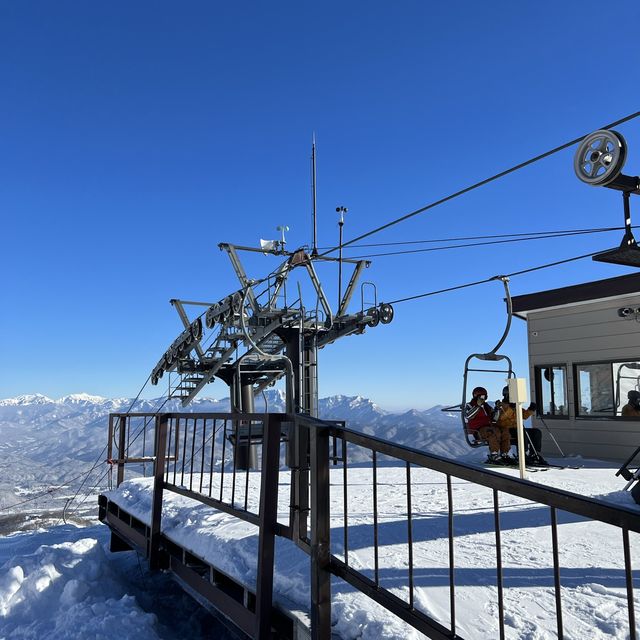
left=151, top=241, right=394, bottom=415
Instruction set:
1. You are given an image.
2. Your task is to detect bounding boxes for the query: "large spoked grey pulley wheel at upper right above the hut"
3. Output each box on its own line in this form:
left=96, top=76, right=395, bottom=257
left=573, top=129, right=627, bottom=186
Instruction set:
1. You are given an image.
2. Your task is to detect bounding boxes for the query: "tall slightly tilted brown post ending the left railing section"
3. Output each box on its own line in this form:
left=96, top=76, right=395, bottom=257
left=255, top=415, right=280, bottom=640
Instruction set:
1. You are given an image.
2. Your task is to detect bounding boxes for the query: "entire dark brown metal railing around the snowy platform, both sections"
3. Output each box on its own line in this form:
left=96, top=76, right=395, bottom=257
left=102, top=414, right=640, bottom=640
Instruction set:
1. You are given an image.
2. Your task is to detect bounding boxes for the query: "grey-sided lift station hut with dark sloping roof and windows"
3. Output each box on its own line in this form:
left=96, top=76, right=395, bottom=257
left=513, top=273, right=640, bottom=461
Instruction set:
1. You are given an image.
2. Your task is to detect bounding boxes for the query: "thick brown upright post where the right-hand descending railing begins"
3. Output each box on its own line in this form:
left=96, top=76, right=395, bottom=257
left=310, top=420, right=331, bottom=640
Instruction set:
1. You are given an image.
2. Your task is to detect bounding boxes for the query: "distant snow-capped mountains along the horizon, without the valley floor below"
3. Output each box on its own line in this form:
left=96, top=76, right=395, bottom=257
left=0, top=389, right=467, bottom=465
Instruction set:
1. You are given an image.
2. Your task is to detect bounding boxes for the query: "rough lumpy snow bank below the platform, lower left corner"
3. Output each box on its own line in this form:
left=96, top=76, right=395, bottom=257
left=0, top=525, right=230, bottom=640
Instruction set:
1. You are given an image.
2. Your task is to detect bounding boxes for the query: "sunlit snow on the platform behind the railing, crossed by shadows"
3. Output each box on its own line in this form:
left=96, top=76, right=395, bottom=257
left=100, top=461, right=640, bottom=640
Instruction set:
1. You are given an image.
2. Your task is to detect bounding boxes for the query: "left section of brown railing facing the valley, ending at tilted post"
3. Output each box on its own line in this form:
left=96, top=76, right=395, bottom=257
left=108, top=413, right=291, bottom=638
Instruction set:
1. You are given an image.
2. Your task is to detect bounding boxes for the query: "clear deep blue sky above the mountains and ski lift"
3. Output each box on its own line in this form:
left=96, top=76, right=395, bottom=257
left=0, top=0, right=640, bottom=408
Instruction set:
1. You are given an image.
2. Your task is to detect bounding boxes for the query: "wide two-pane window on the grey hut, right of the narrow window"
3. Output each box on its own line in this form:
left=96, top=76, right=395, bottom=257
left=575, top=361, right=640, bottom=418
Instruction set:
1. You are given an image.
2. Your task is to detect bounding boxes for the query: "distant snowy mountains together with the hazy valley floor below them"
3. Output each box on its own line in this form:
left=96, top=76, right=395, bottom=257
left=0, top=389, right=469, bottom=533
